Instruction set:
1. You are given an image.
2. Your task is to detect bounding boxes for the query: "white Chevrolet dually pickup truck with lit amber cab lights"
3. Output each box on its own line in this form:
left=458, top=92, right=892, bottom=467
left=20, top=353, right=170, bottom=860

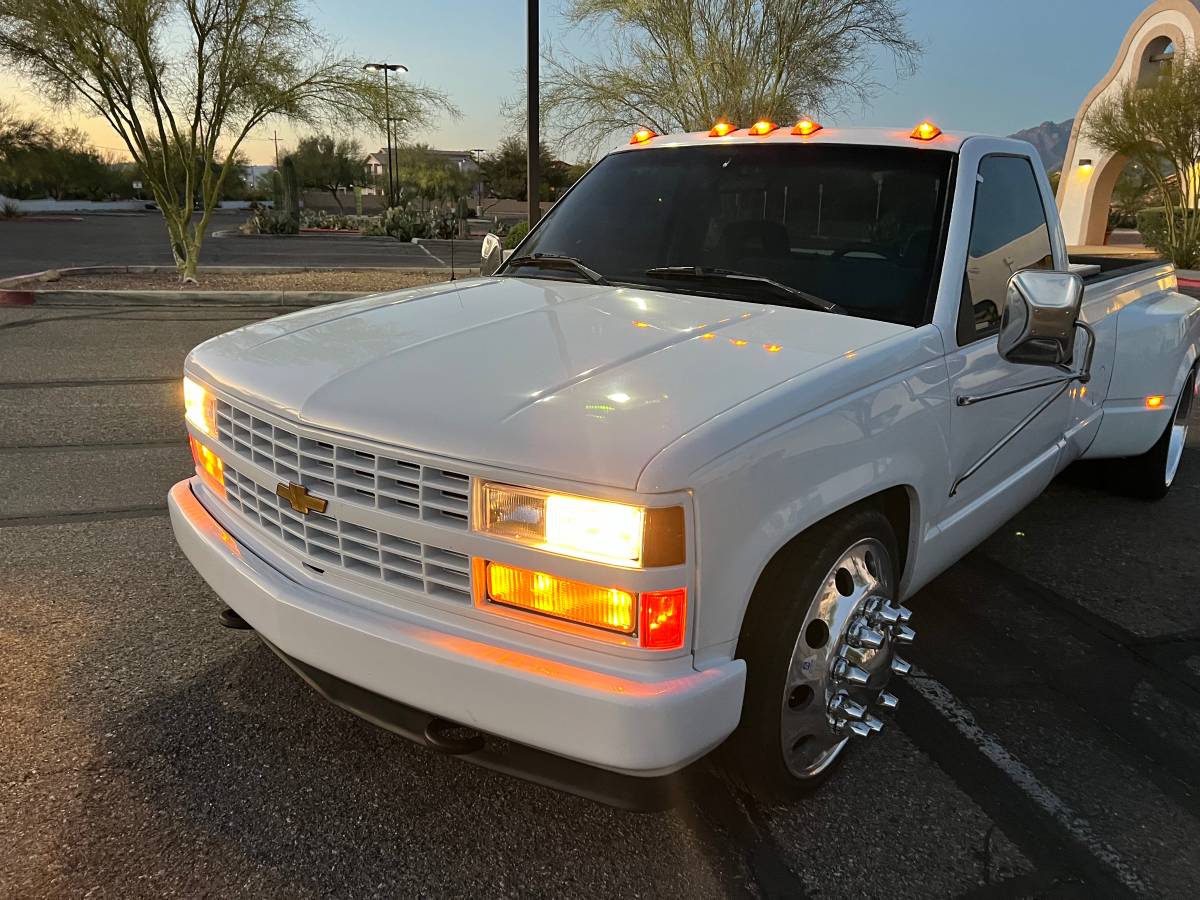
left=169, top=122, right=1200, bottom=806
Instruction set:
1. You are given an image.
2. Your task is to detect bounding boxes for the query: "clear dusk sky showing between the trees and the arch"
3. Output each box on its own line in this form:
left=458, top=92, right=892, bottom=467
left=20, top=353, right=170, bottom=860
left=0, top=0, right=1161, bottom=162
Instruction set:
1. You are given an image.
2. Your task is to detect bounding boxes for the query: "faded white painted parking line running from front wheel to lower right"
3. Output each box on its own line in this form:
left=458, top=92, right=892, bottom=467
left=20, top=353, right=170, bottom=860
left=907, top=666, right=1151, bottom=895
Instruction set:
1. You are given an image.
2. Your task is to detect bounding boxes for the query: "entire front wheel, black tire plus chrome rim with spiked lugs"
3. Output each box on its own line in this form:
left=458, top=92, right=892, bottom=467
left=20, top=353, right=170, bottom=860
left=727, top=509, right=914, bottom=800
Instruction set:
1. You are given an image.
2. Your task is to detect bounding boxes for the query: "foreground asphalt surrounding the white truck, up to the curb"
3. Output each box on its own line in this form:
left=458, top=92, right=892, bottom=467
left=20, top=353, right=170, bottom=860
left=0, top=292, right=1200, bottom=898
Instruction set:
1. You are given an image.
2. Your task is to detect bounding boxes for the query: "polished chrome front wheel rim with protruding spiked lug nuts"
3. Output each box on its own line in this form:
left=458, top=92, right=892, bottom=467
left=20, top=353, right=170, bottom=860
left=780, top=539, right=916, bottom=778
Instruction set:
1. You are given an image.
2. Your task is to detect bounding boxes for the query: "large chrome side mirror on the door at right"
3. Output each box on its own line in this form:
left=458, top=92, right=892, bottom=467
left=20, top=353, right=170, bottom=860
left=997, top=269, right=1084, bottom=366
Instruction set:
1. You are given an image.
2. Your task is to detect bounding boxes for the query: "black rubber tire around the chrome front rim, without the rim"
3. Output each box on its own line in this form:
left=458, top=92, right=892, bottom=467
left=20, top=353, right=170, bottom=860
left=724, top=508, right=900, bottom=802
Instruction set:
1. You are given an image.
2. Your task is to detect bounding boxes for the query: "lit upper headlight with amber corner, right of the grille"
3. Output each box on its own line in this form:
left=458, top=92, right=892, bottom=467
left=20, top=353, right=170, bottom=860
left=480, top=484, right=684, bottom=566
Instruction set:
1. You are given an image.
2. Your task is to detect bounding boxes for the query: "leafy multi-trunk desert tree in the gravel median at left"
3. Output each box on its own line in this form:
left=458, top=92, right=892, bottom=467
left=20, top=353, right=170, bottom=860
left=0, top=0, right=449, bottom=282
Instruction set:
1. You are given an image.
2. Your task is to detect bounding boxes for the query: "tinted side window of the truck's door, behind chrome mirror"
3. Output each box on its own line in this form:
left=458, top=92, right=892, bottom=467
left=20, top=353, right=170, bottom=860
left=958, top=156, right=1054, bottom=346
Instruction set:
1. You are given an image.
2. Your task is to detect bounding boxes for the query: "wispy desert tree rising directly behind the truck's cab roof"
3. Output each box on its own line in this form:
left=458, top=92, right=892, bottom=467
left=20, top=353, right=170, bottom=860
left=541, top=0, right=919, bottom=151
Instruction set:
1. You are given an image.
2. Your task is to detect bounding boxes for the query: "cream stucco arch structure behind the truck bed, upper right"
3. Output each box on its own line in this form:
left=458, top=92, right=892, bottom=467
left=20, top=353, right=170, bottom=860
left=1057, top=0, right=1200, bottom=246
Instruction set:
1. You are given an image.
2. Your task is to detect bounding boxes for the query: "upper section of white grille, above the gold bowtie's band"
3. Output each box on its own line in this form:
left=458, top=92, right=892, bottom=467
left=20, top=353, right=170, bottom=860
left=217, top=400, right=470, bottom=530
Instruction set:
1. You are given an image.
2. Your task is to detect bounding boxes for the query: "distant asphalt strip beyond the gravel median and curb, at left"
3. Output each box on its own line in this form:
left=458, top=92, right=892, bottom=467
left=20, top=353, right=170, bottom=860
left=0, top=210, right=480, bottom=278
